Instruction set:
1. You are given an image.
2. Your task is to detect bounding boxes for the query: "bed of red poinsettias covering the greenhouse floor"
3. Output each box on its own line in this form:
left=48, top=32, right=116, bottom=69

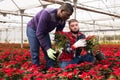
left=0, top=44, right=120, bottom=80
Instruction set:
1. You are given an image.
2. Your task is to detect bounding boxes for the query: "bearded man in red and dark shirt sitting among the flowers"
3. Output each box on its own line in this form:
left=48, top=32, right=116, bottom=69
left=59, top=19, right=95, bottom=68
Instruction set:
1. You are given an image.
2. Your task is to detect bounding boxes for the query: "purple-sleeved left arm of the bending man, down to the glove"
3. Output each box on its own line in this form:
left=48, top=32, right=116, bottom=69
left=36, top=10, right=51, bottom=50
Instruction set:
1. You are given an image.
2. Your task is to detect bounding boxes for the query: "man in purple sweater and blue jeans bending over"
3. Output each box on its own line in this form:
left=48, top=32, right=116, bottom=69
left=27, top=3, right=73, bottom=69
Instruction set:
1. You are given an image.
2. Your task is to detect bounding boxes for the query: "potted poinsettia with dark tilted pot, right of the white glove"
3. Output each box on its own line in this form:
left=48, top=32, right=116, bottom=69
left=81, top=35, right=105, bottom=61
